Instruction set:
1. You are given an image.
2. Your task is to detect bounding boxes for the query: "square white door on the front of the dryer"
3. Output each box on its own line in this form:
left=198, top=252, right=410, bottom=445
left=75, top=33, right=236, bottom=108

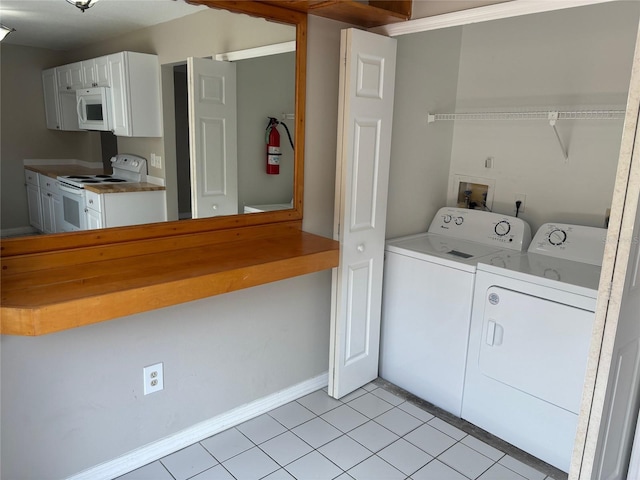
left=479, top=286, right=594, bottom=413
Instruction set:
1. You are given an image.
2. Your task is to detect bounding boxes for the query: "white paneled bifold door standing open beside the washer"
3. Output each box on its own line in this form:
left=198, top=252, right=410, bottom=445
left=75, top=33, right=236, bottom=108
left=329, top=29, right=396, bottom=398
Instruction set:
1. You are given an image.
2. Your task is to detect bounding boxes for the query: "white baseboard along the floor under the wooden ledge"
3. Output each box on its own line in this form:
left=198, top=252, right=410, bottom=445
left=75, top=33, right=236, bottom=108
left=67, top=373, right=329, bottom=480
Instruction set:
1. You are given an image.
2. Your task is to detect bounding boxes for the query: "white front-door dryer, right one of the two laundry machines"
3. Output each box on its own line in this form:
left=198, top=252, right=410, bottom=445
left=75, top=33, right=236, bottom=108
left=462, top=224, right=606, bottom=472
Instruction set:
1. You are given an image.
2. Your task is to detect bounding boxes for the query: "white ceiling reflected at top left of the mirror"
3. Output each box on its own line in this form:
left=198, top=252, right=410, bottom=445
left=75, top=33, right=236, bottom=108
left=0, top=0, right=207, bottom=50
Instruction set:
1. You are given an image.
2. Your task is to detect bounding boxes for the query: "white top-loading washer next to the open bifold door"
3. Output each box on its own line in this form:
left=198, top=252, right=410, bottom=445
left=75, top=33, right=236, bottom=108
left=379, top=207, right=531, bottom=416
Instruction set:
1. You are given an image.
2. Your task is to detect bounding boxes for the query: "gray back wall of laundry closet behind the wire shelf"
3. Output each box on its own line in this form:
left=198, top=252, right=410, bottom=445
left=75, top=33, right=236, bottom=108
left=450, top=2, right=640, bottom=231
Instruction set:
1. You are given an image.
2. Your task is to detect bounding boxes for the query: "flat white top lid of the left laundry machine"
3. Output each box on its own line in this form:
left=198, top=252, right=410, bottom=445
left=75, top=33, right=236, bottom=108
left=386, top=233, right=513, bottom=272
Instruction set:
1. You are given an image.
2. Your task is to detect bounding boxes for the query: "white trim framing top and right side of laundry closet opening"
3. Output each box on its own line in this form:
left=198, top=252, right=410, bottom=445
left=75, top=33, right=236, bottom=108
left=370, top=0, right=640, bottom=480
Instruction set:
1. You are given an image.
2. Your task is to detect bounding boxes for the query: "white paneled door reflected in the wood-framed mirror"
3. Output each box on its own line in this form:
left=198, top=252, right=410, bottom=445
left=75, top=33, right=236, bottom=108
left=187, top=57, right=238, bottom=218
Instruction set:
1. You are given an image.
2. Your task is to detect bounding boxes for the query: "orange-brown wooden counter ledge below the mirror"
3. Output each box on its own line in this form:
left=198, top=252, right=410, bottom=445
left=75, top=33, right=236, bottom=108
left=0, top=222, right=339, bottom=335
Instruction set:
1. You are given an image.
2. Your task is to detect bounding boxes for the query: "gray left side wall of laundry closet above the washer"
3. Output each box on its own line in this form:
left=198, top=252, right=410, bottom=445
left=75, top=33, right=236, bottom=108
left=386, top=28, right=462, bottom=238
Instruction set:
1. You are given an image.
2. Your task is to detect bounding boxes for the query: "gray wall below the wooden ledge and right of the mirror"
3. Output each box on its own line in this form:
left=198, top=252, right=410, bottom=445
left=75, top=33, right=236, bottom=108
left=0, top=18, right=348, bottom=480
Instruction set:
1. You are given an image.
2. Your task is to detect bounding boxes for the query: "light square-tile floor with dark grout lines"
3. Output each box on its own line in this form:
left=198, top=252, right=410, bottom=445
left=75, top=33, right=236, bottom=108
left=118, top=379, right=566, bottom=480
